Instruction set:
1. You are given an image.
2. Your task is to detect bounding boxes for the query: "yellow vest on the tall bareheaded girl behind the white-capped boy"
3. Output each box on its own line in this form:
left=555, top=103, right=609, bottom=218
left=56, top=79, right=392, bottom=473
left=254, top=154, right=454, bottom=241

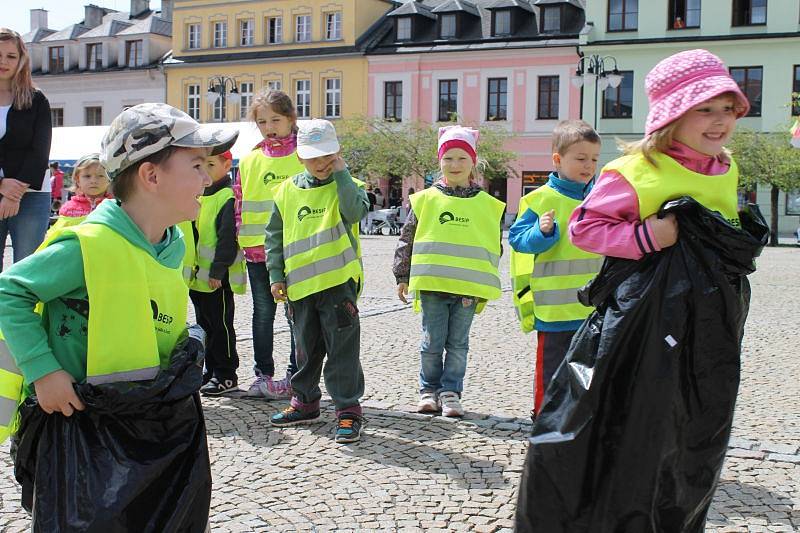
left=239, top=147, right=305, bottom=248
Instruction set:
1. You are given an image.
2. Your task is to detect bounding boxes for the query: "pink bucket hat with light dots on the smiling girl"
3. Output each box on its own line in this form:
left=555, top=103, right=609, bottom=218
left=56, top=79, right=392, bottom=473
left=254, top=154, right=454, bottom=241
left=644, top=49, right=750, bottom=135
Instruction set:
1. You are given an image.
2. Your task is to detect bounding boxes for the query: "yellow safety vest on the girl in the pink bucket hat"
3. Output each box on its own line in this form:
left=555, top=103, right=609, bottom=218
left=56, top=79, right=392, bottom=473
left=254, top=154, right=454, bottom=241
left=601, top=153, right=740, bottom=227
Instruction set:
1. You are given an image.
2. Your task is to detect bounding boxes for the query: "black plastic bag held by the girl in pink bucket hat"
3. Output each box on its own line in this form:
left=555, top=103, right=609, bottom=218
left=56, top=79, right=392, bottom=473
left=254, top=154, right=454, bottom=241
left=516, top=198, right=769, bottom=533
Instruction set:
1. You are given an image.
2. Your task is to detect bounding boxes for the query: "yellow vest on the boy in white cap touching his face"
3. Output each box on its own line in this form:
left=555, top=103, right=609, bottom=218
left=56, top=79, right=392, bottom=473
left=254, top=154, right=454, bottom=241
left=275, top=175, right=364, bottom=301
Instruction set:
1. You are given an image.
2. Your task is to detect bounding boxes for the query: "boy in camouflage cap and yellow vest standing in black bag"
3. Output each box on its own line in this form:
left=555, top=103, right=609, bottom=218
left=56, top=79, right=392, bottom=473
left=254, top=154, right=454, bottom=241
left=0, top=104, right=237, bottom=532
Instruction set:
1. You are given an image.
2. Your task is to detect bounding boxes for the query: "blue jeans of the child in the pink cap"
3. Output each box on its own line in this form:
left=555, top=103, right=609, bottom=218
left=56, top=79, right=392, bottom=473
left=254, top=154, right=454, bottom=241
left=419, top=292, right=476, bottom=395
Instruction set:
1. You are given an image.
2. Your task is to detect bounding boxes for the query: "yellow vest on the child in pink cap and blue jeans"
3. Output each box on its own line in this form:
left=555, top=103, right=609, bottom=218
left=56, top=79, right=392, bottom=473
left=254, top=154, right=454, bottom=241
left=408, top=187, right=505, bottom=308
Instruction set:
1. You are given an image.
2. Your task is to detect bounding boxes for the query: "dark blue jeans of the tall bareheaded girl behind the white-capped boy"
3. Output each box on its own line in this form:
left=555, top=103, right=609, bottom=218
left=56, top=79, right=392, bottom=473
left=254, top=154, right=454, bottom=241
left=247, top=261, right=297, bottom=376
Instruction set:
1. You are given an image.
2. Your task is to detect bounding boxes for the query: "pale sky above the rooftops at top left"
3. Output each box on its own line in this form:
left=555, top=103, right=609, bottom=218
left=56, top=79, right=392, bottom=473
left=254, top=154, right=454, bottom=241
left=7, top=0, right=161, bottom=33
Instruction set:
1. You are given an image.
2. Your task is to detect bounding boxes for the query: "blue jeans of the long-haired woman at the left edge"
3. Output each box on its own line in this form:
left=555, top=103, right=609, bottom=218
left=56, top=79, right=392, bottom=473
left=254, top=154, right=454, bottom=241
left=0, top=191, right=50, bottom=272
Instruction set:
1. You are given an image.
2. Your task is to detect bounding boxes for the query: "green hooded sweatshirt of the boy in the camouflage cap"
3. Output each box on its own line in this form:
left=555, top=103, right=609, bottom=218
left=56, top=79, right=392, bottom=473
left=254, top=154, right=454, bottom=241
left=0, top=201, right=188, bottom=385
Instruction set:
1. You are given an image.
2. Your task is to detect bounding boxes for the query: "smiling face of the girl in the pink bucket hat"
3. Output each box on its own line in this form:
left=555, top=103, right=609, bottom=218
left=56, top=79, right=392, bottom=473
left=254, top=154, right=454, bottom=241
left=672, top=96, right=736, bottom=156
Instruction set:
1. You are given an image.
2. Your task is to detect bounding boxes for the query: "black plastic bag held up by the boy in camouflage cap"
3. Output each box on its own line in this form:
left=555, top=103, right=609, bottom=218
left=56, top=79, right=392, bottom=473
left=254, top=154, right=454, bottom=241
left=11, top=330, right=211, bottom=533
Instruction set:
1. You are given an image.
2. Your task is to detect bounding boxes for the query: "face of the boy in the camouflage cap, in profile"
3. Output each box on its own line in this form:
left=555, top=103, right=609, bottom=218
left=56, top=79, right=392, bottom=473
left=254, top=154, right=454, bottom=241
left=157, top=148, right=211, bottom=225
